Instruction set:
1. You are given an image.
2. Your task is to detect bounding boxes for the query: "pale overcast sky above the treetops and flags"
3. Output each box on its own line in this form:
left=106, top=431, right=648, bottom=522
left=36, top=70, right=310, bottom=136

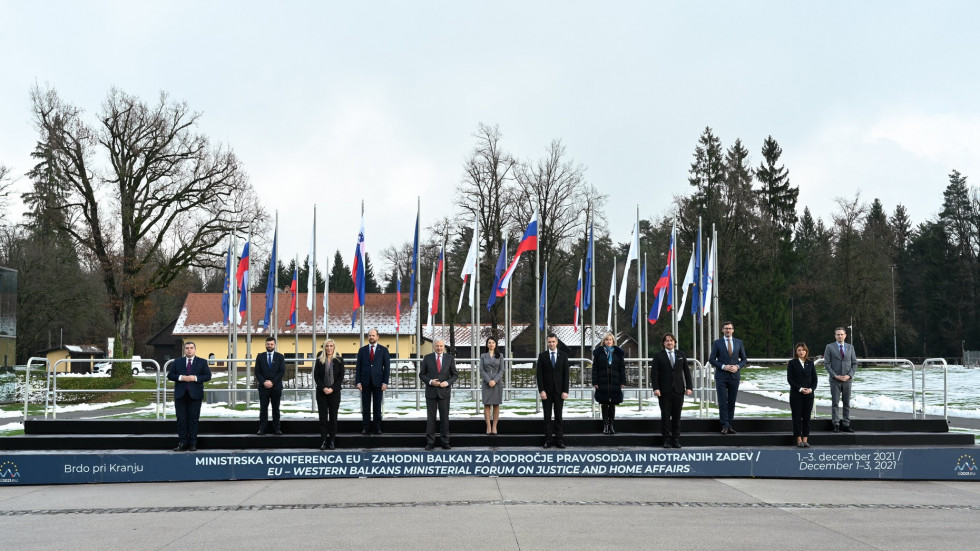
left=0, top=0, right=980, bottom=276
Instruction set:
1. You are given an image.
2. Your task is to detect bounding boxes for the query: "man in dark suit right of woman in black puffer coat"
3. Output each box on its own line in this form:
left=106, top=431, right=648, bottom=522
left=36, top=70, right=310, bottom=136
left=650, top=333, right=694, bottom=448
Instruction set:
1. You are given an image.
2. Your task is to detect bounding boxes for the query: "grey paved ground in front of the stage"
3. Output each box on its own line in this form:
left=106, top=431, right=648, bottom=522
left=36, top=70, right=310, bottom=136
left=0, top=478, right=980, bottom=551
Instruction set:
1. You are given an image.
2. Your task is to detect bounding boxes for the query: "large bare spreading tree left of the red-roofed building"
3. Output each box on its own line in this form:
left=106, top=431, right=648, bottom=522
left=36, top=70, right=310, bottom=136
left=31, top=87, right=266, bottom=373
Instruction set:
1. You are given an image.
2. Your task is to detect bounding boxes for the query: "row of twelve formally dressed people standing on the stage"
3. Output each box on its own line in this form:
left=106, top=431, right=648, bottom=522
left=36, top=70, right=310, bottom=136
left=167, top=322, right=857, bottom=451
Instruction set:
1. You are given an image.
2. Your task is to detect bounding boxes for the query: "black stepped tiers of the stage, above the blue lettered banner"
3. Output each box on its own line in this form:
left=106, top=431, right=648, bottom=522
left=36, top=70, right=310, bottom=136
left=0, top=418, right=974, bottom=450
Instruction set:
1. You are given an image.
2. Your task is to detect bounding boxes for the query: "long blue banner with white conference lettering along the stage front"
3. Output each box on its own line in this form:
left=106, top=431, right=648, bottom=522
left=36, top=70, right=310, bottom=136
left=0, top=447, right=980, bottom=487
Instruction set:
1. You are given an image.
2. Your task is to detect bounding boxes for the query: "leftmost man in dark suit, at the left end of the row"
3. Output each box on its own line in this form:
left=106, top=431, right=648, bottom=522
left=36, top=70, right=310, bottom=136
left=167, top=341, right=211, bottom=452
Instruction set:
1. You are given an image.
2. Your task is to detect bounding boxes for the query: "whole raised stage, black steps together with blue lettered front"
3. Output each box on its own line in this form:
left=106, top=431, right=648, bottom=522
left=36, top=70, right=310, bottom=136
left=0, top=418, right=980, bottom=486
